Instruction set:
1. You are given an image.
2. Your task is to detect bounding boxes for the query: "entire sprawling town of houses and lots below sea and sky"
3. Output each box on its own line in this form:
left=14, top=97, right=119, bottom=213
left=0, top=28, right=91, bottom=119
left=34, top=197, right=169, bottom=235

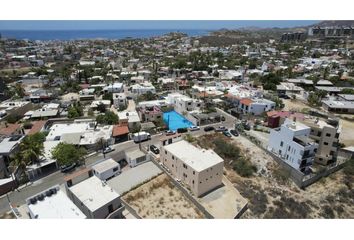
left=0, top=21, right=354, bottom=219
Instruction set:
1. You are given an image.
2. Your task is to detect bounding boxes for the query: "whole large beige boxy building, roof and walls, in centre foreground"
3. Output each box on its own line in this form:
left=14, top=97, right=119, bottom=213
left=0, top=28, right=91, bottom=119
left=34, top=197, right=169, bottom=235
left=160, top=140, right=224, bottom=197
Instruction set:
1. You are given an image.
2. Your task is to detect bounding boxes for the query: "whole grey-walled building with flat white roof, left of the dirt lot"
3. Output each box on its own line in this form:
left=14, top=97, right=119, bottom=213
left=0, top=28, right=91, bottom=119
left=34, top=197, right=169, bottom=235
left=66, top=171, right=124, bottom=219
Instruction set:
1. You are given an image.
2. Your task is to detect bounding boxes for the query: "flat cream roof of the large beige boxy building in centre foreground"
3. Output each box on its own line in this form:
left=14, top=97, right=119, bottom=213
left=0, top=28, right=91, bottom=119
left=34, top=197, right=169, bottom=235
left=164, top=140, right=224, bottom=172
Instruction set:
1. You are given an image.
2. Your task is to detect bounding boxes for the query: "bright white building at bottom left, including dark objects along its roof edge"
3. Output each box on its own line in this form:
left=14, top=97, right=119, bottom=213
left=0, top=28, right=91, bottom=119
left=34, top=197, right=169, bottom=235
left=26, top=185, right=86, bottom=219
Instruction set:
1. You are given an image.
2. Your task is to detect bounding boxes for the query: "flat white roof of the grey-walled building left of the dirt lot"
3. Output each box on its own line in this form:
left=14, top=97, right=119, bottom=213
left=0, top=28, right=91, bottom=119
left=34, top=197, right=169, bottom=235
left=70, top=176, right=120, bottom=212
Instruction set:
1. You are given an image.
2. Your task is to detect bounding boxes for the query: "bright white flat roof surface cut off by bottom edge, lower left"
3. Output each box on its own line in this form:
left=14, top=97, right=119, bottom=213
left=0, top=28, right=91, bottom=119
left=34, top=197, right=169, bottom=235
left=27, top=190, right=86, bottom=219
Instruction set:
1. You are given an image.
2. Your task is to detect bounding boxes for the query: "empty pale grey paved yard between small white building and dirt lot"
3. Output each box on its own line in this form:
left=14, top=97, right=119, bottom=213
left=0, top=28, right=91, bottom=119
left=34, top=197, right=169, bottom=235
left=107, top=162, right=162, bottom=195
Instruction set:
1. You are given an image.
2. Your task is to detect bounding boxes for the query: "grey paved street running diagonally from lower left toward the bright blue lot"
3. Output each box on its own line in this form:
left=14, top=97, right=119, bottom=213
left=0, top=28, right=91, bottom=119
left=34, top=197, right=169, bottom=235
left=0, top=111, right=235, bottom=215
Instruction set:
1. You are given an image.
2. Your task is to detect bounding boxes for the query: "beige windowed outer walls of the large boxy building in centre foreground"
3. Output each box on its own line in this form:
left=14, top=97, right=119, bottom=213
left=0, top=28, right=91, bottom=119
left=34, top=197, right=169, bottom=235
left=160, top=147, right=224, bottom=196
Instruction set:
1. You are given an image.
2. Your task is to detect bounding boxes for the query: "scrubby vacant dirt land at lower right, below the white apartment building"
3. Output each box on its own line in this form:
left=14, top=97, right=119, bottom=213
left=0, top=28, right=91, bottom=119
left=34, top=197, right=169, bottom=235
left=199, top=136, right=354, bottom=218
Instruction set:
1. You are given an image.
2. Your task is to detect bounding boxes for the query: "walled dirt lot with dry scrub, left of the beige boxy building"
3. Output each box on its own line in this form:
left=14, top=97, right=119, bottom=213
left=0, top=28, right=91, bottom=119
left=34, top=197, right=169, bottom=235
left=123, top=174, right=204, bottom=219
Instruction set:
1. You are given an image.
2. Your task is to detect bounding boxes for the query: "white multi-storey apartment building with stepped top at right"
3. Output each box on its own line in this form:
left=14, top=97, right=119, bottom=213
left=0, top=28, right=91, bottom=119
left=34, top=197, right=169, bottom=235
left=268, top=119, right=318, bottom=172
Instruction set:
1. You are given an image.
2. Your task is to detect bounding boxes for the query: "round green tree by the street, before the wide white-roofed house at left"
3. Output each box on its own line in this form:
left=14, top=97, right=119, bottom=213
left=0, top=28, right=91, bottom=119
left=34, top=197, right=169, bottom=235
left=52, top=142, right=87, bottom=166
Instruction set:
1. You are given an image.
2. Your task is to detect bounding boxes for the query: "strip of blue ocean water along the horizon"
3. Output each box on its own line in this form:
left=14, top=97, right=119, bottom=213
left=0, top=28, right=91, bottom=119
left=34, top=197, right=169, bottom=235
left=0, top=29, right=209, bottom=40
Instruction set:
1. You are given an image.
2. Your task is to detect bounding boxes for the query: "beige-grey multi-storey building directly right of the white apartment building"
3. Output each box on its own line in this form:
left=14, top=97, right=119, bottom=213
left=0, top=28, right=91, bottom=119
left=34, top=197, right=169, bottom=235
left=302, top=118, right=340, bottom=165
